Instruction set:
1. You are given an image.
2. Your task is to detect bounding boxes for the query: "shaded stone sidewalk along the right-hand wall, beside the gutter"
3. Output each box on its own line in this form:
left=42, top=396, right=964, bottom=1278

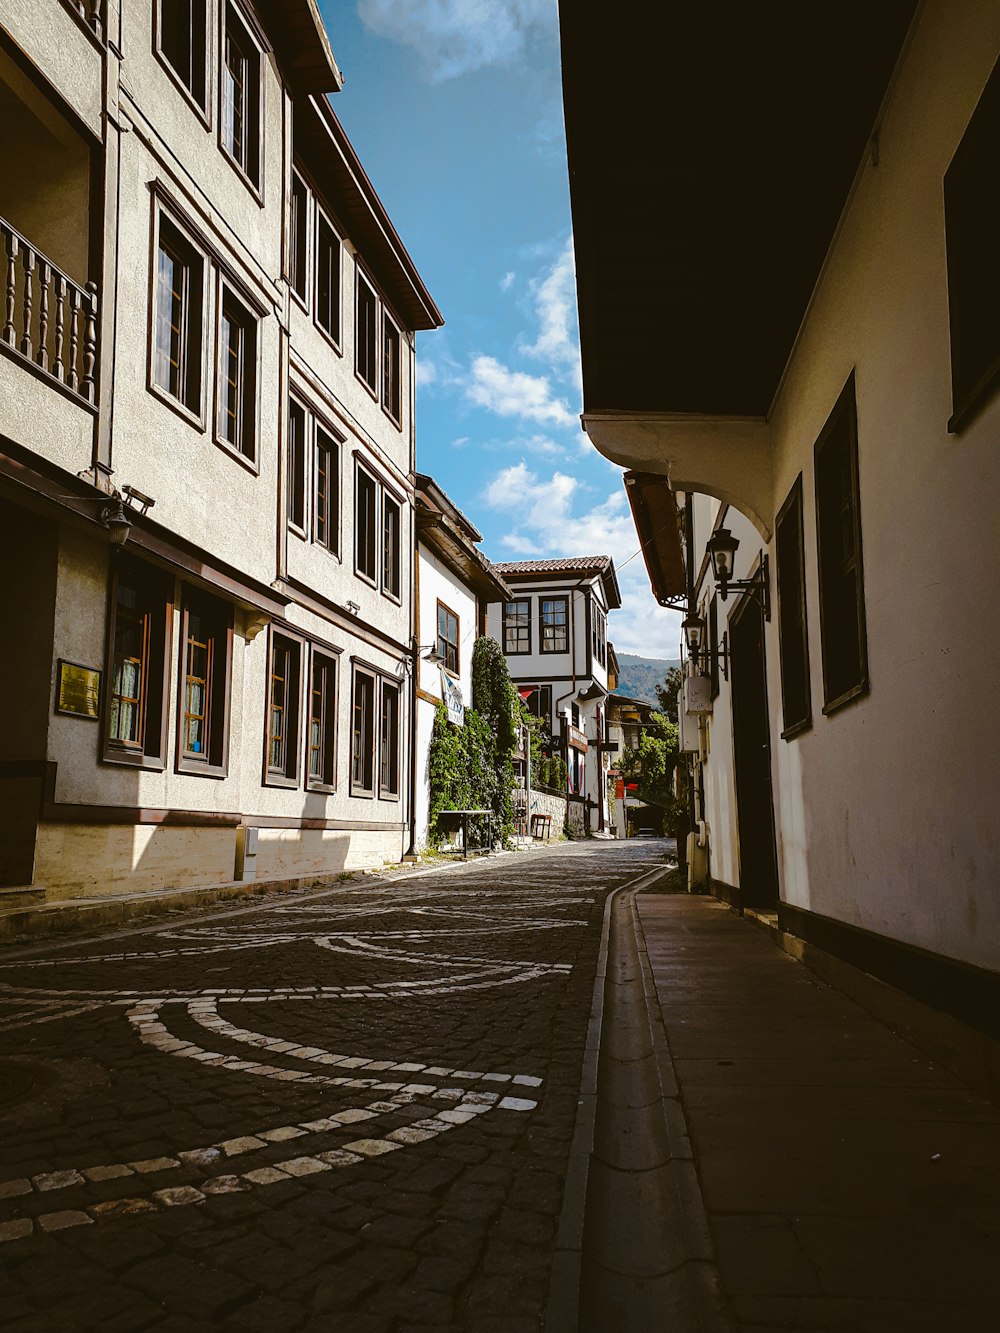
left=637, top=894, right=1000, bottom=1333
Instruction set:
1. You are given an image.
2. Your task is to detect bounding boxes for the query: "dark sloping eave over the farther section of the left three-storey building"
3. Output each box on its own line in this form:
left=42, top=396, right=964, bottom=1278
left=295, top=96, right=444, bottom=329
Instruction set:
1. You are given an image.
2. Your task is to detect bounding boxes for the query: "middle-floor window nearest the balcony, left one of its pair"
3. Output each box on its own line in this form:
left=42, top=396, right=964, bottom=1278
left=152, top=213, right=205, bottom=416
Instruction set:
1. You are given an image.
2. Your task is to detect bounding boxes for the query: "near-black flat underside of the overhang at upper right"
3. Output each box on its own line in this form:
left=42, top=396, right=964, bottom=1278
left=560, top=0, right=916, bottom=417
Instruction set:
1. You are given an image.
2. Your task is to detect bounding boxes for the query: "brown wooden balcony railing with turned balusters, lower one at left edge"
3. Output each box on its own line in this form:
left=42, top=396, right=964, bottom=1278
left=0, top=217, right=97, bottom=403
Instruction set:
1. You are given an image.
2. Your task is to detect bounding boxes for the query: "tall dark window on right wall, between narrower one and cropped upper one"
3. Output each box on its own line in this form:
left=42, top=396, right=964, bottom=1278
left=815, top=375, right=868, bottom=713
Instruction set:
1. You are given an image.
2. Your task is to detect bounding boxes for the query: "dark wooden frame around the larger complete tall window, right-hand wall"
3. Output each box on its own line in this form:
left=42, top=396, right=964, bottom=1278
left=813, top=372, right=869, bottom=717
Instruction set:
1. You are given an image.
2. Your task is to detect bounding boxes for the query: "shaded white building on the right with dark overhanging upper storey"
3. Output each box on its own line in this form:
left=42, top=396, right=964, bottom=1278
left=560, top=0, right=1000, bottom=1037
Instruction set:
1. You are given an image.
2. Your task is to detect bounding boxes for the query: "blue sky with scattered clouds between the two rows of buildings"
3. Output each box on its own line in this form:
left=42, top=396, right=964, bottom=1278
left=320, top=0, right=679, bottom=657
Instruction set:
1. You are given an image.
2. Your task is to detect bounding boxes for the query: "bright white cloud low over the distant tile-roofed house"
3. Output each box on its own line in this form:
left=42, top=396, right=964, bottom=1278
left=485, top=461, right=680, bottom=657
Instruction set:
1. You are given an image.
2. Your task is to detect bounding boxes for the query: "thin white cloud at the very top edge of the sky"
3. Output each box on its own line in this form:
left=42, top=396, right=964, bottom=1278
left=357, top=0, right=556, bottom=83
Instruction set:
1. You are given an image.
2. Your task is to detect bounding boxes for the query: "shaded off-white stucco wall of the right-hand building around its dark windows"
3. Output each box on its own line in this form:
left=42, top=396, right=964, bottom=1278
left=699, top=0, right=1000, bottom=968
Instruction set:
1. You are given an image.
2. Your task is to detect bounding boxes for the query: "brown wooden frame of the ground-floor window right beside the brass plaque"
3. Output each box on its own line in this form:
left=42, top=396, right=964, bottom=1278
left=100, top=553, right=173, bottom=772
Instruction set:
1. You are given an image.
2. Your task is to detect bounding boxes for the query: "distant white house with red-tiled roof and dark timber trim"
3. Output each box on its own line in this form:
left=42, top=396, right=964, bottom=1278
left=488, top=556, right=621, bottom=832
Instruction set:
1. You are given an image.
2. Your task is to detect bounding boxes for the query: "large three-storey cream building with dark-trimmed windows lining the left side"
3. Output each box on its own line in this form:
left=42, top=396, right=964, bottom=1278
left=0, top=0, right=441, bottom=897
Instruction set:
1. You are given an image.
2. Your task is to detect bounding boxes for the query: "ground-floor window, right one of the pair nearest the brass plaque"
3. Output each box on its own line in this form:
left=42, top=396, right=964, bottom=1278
left=177, top=592, right=232, bottom=774
